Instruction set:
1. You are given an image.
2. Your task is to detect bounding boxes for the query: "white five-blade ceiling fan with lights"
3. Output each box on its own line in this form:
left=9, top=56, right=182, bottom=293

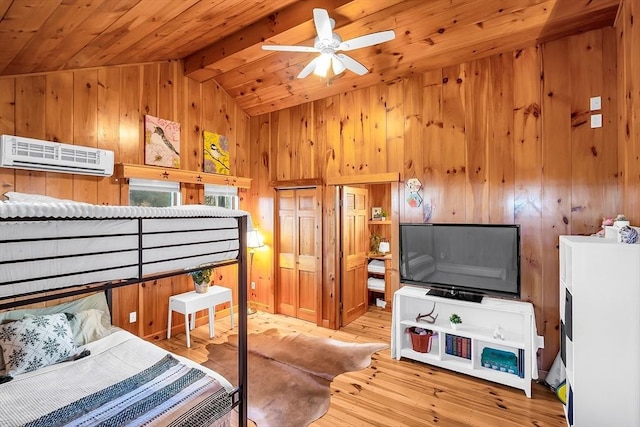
left=262, top=8, right=396, bottom=79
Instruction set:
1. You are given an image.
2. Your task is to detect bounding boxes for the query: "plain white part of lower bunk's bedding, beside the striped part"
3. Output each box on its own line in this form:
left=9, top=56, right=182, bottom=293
left=0, top=328, right=233, bottom=427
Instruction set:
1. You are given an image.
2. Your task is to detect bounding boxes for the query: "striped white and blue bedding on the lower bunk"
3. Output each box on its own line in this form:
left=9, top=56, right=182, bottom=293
left=0, top=329, right=233, bottom=427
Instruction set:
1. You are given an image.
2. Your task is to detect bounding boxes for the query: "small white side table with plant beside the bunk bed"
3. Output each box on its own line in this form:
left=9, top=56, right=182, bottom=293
left=167, top=285, right=233, bottom=347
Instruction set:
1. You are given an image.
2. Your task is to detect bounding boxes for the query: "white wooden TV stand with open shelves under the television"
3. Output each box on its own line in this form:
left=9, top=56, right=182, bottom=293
left=391, top=286, right=544, bottom=398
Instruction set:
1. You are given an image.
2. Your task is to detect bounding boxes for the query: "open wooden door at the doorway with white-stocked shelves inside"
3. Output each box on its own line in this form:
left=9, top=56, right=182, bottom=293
left=341, top=186, right=369, bottom=326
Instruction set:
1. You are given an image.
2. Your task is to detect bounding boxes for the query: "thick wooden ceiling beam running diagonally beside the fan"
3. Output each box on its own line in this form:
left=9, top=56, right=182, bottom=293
left=184, top=0, right=351, bottom=81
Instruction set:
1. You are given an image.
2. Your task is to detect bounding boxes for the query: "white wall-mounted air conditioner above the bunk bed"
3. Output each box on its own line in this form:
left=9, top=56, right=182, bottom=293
left=0, top=135, right=114, bottom=176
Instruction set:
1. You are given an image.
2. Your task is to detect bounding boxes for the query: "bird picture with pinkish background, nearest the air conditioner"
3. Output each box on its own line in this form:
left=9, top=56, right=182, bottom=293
left=144, top=115, right=180, bottom=168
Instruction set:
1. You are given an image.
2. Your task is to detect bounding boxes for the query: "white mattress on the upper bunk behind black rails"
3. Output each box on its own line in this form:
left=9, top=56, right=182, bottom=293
left=0, top=202, right=253, bottom=298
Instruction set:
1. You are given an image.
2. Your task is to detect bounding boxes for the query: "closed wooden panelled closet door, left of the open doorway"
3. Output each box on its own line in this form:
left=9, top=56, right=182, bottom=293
left=276, top=188, right=322, bottom=324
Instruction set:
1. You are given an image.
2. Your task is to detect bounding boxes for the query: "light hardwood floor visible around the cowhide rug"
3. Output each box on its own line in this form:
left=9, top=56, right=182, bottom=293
left=156, top=306, right=566, bottom=427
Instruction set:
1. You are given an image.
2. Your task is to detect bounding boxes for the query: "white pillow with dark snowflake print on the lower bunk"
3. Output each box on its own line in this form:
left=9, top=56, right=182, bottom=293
left=0, top=313, right=77, bottom=375
